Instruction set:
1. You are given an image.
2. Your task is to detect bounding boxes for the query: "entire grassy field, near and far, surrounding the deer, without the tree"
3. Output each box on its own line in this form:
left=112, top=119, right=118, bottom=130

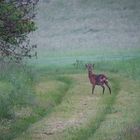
left=0, top=0, right=140, bottom=140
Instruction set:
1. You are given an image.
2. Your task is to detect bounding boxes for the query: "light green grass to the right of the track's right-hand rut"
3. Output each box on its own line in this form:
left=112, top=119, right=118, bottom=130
left=88, top=78, right=140, bottom=140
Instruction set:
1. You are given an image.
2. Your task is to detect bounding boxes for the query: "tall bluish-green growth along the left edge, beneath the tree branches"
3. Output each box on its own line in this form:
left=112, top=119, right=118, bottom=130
left=0, top=62, right=35, bottom=140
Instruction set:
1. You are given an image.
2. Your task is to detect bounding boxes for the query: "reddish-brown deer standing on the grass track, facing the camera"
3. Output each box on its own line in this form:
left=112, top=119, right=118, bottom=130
left=86, top=64, right=111, bottom=94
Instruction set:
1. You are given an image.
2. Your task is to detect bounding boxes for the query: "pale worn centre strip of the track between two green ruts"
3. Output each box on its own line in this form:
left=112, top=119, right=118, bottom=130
left=17, top=74, right=105, bottom=140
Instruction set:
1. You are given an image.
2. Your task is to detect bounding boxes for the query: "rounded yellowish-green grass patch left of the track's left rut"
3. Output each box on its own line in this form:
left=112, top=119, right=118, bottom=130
left=16, top=76, right=72, bottom=139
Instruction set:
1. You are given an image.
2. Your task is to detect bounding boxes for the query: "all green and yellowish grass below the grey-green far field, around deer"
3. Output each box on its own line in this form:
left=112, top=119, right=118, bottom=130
left=0, top=59, right=140, bottom=140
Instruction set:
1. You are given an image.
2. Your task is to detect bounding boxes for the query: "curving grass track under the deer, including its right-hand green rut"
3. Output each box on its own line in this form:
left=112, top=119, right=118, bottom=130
left=15, top=74, right=126, bottom=140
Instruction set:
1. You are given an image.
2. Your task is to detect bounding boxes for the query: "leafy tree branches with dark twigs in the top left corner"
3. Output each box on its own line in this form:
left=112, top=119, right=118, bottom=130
left=0, top=0, right=38, bottom=61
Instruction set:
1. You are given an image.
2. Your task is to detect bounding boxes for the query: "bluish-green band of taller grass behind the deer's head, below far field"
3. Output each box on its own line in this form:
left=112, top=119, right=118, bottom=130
left=34, top=58, right=140, bottom=79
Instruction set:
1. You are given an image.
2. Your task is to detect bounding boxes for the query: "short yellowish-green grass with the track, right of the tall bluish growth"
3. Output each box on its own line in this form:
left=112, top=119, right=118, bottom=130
left=14, top=61, right=140, bottom=140
